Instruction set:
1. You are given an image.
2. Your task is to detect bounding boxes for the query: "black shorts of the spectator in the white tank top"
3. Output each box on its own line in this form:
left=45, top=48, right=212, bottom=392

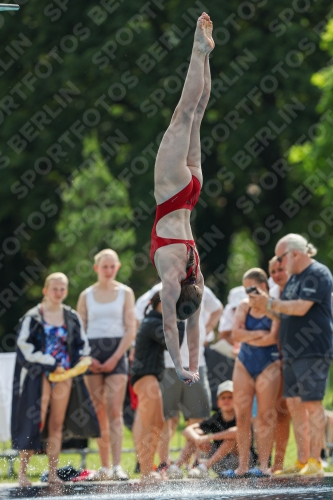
left=87, top=337, right=128, bottom=377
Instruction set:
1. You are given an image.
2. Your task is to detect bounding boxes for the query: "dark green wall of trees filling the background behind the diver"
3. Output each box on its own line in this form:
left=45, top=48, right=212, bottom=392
left=0, top=0, right=332, bottom=348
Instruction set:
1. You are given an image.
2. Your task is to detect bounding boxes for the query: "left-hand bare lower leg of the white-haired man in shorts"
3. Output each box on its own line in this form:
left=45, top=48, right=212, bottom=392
left=287, top=398, right=310, bottom=464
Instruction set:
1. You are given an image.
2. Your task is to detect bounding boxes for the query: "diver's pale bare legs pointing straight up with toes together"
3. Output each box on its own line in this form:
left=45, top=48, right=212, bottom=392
left=155, top=13, right=214, bottom=204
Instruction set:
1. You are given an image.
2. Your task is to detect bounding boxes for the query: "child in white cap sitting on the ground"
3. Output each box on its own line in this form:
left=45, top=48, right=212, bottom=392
left=183, top=380, right=238, bottom=479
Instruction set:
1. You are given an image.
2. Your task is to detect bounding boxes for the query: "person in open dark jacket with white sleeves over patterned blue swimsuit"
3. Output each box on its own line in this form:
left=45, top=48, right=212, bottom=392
left=11, top=273, right=99, bottom=486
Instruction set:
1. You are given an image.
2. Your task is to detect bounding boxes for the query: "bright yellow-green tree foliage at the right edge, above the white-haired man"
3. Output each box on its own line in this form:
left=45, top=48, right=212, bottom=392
left=289, top=20, right=333, bottom=268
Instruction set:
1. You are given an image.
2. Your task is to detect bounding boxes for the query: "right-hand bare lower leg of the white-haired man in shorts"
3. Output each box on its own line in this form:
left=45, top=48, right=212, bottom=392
left=303, top=401, right=325, bottom=460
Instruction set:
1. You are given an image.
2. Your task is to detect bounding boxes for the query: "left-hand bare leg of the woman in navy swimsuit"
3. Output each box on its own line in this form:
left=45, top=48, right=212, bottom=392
left=233, top=360, right=254, bottom=475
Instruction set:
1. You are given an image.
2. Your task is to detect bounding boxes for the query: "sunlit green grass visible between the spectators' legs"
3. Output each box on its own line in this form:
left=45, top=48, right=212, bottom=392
left=0, top=366, right=333, bottom=482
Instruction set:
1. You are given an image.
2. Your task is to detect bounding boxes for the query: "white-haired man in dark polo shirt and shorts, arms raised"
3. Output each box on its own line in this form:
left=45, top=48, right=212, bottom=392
left=251, top=234, right=333, bottom=476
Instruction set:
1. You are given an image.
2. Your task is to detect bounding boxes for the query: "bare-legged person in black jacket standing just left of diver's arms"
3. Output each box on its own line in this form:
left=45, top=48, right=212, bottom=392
left=131, top=292, right=185, bottom=480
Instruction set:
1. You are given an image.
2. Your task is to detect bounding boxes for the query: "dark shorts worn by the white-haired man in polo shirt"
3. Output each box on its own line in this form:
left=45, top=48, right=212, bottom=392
left=282, top=357, right=331, bottom=401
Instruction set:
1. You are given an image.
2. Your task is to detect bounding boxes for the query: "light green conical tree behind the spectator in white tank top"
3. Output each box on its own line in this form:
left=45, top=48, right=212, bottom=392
left=44, top=136, right=135, bottom=307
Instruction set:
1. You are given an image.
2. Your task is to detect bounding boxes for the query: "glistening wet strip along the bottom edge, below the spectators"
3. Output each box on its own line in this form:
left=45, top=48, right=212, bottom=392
left=0, top=473, right=333, bottom=500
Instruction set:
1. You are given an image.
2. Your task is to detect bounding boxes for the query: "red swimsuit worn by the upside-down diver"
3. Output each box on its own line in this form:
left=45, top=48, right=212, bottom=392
left=150, top=175, right=201, bottom=279
